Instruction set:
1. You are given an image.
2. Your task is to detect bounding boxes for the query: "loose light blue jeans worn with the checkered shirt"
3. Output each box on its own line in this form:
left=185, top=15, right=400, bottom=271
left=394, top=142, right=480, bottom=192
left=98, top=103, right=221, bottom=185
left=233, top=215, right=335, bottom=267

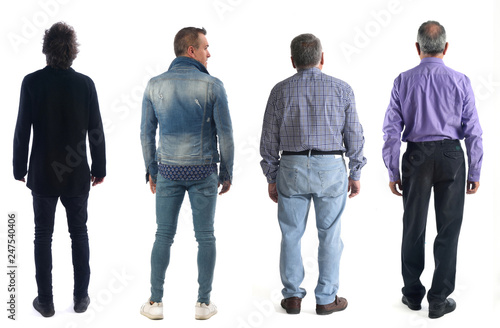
left=277, top=155, right=347, bottom=305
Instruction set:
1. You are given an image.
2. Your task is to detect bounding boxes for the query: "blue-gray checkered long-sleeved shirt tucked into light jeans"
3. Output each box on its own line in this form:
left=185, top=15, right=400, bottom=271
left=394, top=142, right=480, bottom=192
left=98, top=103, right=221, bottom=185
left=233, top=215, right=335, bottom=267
left=260, top=67, right=366, bottom=183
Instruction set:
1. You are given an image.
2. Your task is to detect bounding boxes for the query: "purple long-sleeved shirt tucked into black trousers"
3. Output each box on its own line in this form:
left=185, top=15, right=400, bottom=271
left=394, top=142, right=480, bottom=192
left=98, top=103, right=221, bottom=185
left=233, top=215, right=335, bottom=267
left=382, top=57, right=483, bottom=181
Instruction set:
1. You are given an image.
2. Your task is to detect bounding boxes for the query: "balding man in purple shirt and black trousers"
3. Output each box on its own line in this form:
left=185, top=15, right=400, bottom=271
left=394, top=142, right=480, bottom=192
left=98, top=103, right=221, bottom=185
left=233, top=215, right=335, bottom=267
left=382, top=21, right=483, bottom=318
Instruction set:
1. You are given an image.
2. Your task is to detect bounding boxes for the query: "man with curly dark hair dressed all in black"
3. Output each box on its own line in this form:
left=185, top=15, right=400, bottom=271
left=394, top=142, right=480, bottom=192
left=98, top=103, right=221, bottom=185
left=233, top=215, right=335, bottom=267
left=13, top=23, right=106, bottom=317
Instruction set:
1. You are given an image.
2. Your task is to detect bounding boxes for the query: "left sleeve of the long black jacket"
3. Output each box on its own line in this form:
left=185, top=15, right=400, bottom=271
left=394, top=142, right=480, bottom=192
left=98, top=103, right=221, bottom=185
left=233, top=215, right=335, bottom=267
left=13, top=78, right=33, bottom=180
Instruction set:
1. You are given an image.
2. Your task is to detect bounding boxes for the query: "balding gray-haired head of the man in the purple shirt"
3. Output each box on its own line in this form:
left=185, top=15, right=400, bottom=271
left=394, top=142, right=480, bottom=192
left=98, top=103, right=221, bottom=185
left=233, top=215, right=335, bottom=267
left=417, top=21, right=446, bottom=55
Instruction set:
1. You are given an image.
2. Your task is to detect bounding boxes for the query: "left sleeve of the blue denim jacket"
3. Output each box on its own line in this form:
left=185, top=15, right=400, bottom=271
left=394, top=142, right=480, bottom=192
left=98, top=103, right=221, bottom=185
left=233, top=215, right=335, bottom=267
left=141, top=83, right=158, bottom=182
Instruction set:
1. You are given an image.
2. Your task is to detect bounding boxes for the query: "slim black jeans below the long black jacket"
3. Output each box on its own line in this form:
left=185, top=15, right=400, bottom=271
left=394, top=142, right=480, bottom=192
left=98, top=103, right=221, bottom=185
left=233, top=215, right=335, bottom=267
left=33, top=193, right=90, bottom=303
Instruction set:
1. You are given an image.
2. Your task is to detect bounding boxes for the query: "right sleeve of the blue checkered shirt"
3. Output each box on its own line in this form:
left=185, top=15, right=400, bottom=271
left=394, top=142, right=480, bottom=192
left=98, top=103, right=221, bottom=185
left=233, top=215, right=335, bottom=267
left=344, top=89, right=367, bottom=180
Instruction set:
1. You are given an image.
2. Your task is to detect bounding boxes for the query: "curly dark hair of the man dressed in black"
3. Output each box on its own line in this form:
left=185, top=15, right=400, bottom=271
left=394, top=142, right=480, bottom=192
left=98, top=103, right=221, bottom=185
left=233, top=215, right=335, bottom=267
left=42, top=22, right=79, bottom=69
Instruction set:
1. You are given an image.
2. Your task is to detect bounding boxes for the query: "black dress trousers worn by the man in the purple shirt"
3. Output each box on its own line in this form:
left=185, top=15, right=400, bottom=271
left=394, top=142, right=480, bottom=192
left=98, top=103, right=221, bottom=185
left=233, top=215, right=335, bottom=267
left=401, top=140, right=465, bottom=304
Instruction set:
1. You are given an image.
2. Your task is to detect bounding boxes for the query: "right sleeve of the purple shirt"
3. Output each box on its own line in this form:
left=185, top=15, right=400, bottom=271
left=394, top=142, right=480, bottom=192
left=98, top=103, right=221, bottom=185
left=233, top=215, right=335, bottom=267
left=462, top=77, right=483, bottom=182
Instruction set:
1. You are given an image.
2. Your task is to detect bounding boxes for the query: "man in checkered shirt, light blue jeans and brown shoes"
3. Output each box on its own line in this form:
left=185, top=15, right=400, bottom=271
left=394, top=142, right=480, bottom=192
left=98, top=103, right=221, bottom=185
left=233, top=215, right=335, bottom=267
left=260, top=34, right=366, bottom=314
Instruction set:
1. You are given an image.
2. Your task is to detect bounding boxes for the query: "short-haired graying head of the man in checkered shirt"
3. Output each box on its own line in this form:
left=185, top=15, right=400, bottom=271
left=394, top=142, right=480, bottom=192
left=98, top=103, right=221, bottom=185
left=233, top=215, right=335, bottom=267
left=290, top=34, right=323, bottom=68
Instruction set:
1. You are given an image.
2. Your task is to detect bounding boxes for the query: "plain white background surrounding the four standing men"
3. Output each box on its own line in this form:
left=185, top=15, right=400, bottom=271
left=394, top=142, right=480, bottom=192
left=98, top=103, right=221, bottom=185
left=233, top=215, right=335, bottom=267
left=0, top=0, right=500, bottom=328
